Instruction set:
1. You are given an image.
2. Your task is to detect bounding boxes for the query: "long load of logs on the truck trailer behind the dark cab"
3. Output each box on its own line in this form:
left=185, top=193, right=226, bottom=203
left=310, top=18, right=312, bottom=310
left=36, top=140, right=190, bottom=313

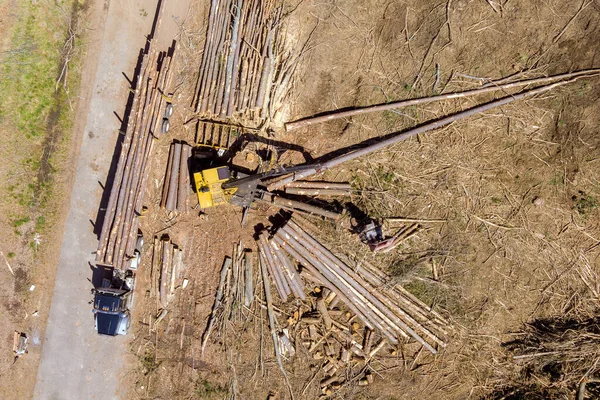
left=96, top=39, right=175, bottom=270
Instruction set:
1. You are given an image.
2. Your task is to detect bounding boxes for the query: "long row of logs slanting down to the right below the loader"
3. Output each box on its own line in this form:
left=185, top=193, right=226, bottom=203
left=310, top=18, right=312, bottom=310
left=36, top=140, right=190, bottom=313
left=270, top=220, right=446, bottom=354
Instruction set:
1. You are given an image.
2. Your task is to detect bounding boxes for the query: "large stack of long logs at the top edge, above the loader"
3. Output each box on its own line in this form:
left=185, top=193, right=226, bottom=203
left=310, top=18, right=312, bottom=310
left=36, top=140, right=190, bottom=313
left=194, top=0, right=283, bottom=121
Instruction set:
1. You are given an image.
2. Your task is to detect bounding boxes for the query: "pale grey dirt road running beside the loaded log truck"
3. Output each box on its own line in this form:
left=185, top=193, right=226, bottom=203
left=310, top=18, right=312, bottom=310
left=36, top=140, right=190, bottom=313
left=34, top=0, right=157, bottom=399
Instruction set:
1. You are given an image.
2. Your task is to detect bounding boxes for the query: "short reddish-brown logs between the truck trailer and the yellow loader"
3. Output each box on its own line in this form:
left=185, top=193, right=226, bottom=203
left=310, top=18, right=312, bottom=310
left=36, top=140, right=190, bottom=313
left=160, top=142, right=192, bottom=212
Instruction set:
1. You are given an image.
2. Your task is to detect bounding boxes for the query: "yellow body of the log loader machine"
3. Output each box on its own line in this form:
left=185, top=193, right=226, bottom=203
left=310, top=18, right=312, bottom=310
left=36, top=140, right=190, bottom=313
left=194, top=167, right=237, bottom=208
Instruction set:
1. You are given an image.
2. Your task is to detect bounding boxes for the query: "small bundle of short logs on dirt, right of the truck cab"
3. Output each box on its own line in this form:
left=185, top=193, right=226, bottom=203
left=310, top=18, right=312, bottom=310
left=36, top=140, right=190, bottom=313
left=151, top=235, right=183, bottom=309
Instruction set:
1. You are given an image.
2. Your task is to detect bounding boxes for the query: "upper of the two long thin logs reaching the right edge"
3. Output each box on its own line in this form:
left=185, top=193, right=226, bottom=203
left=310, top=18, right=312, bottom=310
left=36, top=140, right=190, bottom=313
left=285, top=69, right=600, bottom=131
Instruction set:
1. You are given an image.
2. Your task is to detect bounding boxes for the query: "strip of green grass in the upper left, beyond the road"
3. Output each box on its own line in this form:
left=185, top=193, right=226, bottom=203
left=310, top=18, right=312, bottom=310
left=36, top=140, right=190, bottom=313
left=0, top=0, right=83, bottom=247
